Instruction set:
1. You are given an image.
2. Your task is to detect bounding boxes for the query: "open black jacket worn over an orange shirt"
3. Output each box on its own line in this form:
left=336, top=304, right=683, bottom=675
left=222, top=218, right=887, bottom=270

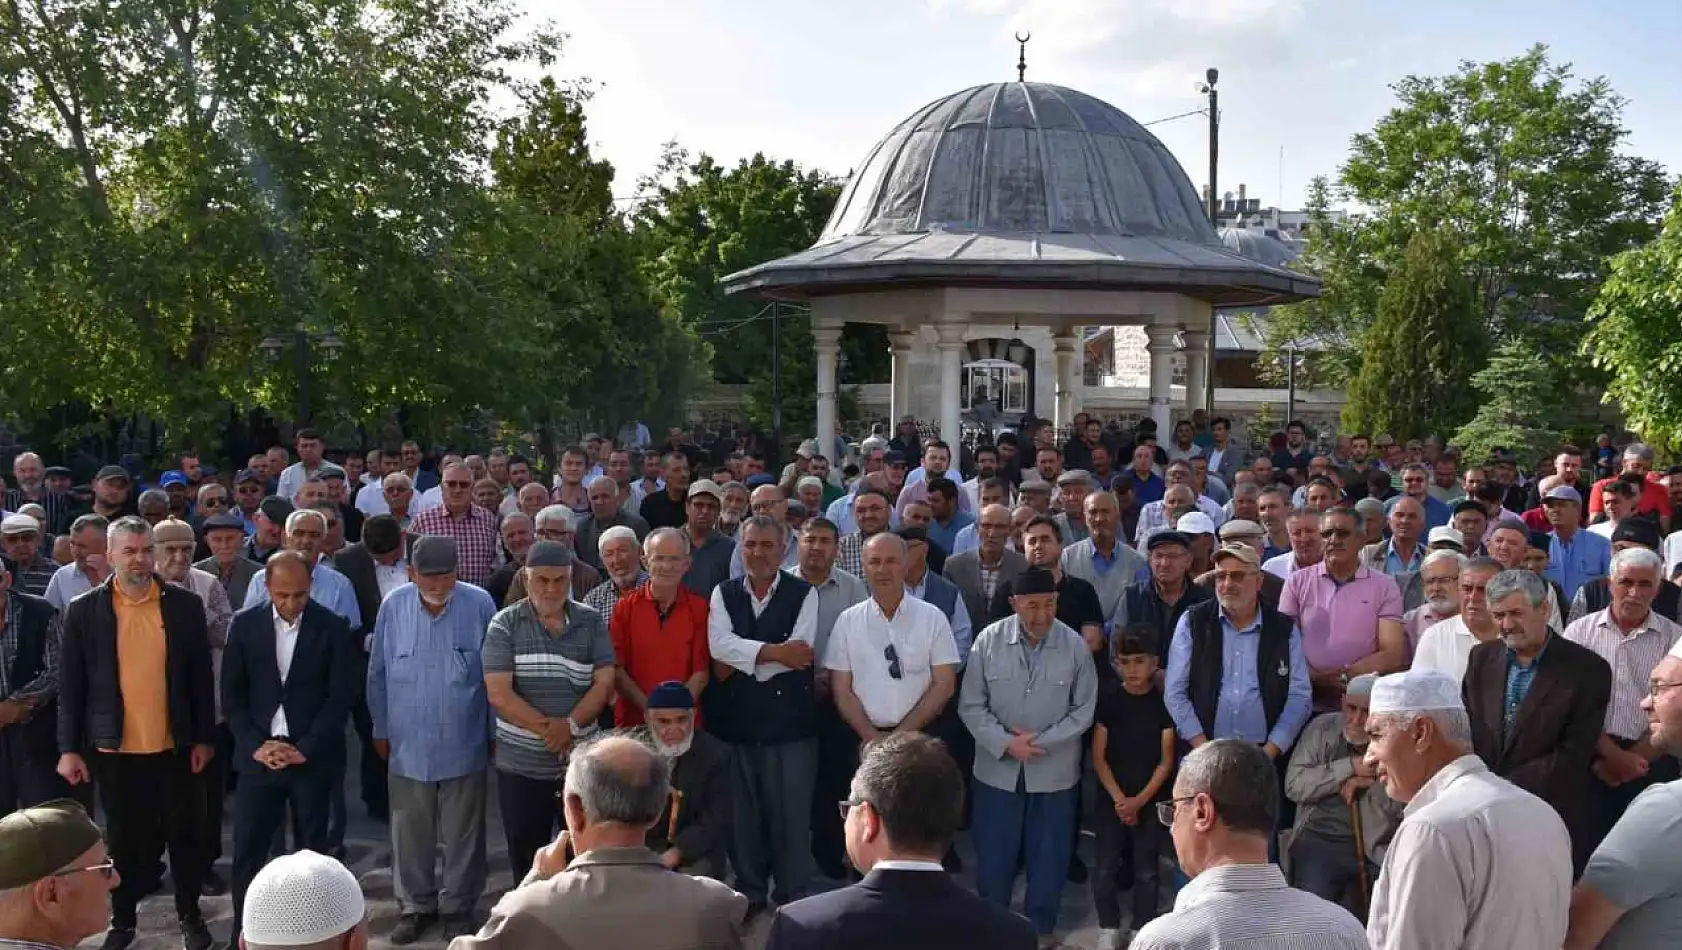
left=59, top=577, right=215, bottom=753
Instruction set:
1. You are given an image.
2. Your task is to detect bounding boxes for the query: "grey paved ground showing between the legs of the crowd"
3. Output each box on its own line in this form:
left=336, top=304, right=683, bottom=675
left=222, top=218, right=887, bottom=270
left=101, top=740, right=1127, bottom=950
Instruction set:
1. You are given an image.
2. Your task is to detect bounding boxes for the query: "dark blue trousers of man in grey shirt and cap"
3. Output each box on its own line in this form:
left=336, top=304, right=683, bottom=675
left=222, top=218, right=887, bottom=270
left=971, top=778, right=1076, bottom=933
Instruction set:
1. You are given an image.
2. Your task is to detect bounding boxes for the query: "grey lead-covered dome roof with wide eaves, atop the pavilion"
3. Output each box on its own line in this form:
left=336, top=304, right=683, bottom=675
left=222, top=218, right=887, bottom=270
left=723, top=82, right=1319, bottom=306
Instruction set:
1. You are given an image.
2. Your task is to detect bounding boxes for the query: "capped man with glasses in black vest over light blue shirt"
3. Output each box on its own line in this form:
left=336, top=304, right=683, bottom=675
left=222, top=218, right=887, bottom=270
left=1166, top=545, right=1312, bottom=762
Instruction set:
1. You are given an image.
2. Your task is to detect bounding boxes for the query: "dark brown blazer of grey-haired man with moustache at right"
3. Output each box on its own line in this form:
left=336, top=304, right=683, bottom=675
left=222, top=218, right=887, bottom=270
left=1462, top=634, right=1611, bottom=861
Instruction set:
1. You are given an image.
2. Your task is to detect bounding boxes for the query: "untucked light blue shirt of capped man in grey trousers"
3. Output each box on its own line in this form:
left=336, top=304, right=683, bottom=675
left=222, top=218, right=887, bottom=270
left=368, top=582, right=496, bottom=782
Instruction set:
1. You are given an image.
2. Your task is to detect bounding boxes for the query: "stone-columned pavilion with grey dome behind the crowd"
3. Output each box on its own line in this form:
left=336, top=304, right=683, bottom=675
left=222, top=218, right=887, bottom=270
left=725, top=82, right=1319, bottom=446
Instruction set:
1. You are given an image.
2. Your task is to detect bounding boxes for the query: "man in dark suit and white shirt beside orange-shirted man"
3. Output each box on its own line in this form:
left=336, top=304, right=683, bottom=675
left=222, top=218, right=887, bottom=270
left=222, top=552, right=357, bottom=945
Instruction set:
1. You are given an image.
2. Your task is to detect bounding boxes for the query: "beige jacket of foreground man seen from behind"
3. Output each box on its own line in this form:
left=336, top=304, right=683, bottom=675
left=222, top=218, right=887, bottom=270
left=449, top=847, right=747, bottom=950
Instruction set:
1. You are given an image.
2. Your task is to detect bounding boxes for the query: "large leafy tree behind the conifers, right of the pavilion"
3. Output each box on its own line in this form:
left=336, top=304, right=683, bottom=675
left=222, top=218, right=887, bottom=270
left=1270, top=45, right=1669, bottom=382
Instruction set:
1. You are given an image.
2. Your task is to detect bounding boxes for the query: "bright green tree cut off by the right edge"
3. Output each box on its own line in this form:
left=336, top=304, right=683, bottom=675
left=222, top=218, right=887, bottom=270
left=1583, top=188, right=1682, bottom=449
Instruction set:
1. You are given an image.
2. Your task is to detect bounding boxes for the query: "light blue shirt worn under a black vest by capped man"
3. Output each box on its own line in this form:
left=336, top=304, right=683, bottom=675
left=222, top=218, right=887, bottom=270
left=1164, top=609, right=1314, bottom=752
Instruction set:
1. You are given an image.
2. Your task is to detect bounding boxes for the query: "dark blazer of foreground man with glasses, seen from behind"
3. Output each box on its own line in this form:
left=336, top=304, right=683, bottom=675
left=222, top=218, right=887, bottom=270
left=765, top=871, right=1039, bottom=950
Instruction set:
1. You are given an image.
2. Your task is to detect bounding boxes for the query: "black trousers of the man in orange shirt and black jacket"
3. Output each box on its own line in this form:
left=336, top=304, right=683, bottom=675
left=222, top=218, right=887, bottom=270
left=87, top=748, right=204, bottom=930
